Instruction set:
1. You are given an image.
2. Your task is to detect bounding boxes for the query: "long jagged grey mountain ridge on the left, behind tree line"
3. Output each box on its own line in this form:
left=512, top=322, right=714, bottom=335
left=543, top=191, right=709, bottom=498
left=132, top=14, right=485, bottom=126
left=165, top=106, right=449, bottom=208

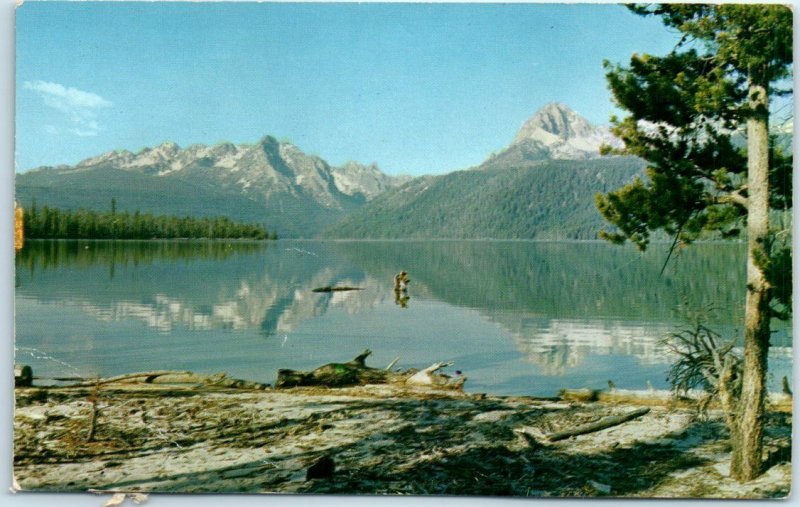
left=17, top=136, right=404, bottom=237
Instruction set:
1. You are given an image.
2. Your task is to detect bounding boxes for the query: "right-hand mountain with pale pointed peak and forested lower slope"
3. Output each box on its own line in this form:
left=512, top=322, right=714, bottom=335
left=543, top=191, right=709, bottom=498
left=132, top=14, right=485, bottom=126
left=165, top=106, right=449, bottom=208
left=323, top=104, right=644, bottom=239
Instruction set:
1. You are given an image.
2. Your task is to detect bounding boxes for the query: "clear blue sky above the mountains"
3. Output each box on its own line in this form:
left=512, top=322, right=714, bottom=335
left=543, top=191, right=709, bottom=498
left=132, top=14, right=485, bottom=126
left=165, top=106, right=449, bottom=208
left=16, top=1, right=677, bottom=174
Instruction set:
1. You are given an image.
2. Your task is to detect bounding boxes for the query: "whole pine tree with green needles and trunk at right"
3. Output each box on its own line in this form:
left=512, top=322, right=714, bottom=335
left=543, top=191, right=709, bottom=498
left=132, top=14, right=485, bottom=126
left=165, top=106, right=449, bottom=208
left=597, top=4, right=793, bottom=481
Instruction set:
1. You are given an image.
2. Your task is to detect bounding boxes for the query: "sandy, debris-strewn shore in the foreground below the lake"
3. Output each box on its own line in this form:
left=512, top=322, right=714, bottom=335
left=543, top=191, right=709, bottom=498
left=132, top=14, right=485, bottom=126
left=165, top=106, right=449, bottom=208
left=14, top=382, right=791, bottom=498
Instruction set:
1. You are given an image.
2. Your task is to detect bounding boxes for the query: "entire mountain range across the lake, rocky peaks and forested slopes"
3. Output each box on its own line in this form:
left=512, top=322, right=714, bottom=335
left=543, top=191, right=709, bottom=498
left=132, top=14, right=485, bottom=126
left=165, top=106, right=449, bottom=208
left=16, top=104, right=644, bottom=239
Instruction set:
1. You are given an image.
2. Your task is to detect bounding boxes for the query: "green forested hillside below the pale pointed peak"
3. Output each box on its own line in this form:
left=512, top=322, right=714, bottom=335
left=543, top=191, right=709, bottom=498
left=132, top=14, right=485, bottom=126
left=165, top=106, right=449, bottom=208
left=324, top=157, right=644, bottom=239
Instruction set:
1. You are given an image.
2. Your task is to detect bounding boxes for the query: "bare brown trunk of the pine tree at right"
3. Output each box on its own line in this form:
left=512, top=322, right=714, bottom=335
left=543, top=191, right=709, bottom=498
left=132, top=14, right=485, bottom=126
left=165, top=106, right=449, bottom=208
left=731, top=82, right=770, bottom=482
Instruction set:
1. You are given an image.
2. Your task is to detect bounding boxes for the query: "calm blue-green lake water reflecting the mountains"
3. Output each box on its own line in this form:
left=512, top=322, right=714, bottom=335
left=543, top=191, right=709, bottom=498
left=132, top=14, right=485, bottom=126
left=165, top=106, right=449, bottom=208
left=16, top=240, right=792, bottom=395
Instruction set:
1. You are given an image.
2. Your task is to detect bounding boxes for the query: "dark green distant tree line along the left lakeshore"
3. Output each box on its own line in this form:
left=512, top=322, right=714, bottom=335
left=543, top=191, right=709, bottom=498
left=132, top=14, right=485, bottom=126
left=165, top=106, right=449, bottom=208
left=24, top=199, right=278, bottom=240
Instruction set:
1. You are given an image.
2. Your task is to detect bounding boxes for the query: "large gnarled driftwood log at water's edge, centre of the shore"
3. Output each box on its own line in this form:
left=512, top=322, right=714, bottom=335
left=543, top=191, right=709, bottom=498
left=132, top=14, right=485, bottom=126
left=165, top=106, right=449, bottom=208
left=275, top=349, right=466, bottom=389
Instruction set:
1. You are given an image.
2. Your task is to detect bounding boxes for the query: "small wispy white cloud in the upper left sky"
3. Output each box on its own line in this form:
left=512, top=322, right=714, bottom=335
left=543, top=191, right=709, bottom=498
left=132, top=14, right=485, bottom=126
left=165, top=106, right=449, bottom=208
left=22, top=81, right=112, bottom=137
